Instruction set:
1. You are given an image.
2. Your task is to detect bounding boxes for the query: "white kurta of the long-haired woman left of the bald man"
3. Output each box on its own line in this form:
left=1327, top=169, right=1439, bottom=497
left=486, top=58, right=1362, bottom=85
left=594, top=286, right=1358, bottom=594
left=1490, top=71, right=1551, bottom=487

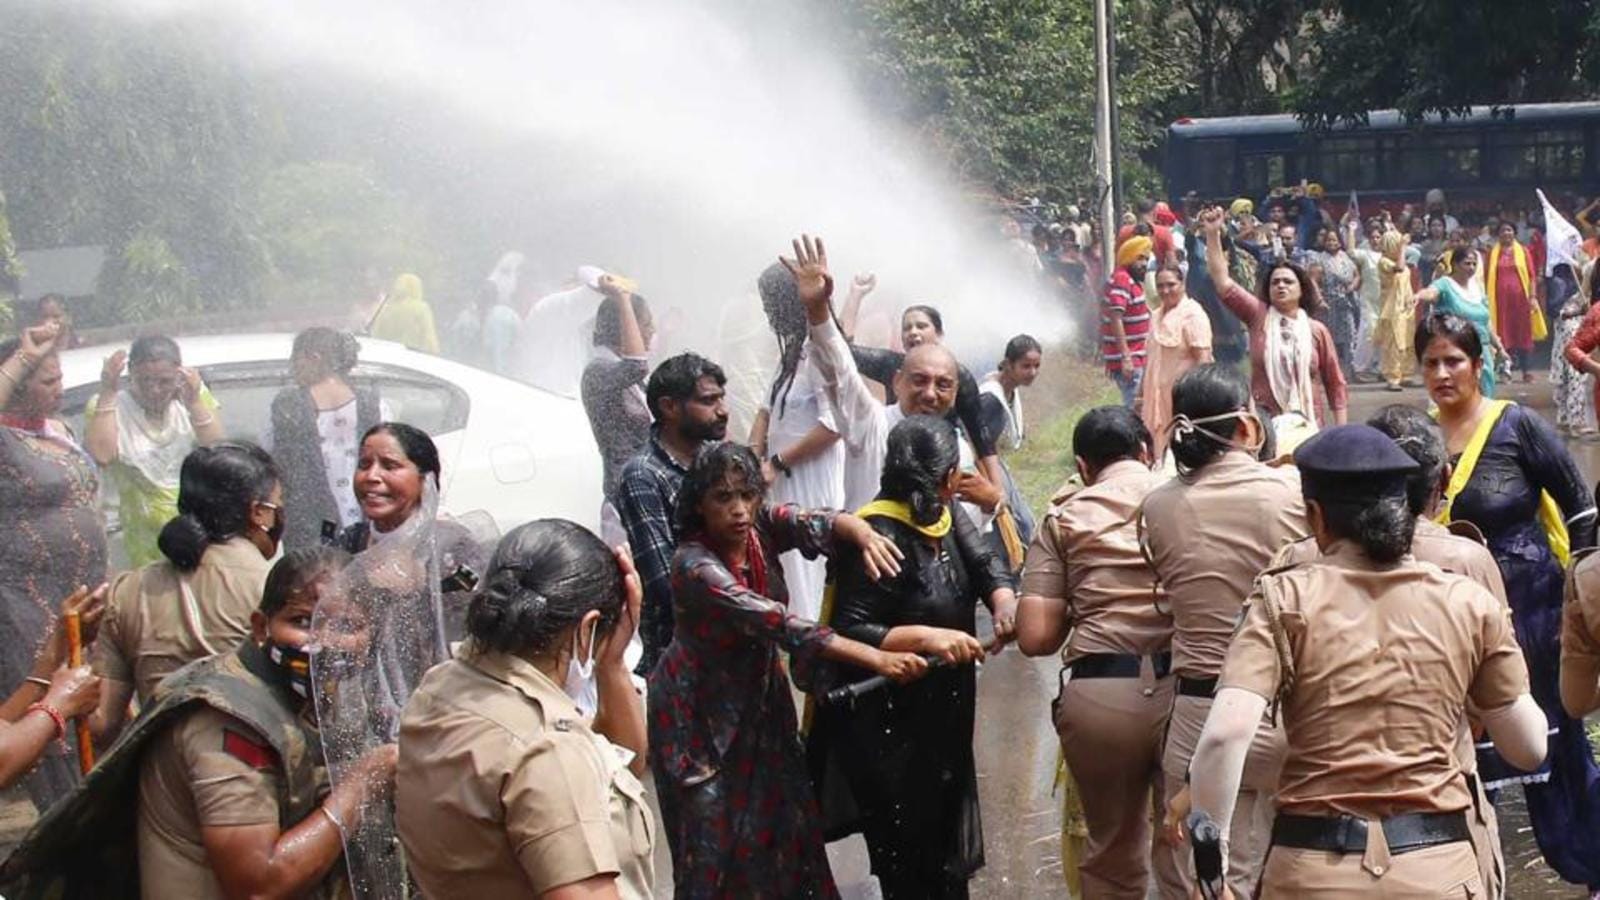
left=766, top=352, right=854, bottom=620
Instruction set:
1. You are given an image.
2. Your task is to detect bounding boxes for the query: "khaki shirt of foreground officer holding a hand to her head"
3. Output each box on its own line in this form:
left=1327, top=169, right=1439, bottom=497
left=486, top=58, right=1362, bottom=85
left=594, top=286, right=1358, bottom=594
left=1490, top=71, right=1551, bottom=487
left=395, top=649, right=654, bottom=900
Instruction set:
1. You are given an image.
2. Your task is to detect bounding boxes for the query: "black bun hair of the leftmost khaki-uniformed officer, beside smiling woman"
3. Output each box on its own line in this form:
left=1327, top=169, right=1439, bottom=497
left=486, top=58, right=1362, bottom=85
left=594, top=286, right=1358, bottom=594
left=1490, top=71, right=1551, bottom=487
left=155, top=440, right=278, bottom=572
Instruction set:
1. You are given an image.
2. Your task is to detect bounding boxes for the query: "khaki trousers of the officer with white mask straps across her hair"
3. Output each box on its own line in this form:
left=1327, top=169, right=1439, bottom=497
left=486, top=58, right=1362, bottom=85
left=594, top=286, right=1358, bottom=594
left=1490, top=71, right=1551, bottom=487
left=1162, top=688, right=1288, bottom=898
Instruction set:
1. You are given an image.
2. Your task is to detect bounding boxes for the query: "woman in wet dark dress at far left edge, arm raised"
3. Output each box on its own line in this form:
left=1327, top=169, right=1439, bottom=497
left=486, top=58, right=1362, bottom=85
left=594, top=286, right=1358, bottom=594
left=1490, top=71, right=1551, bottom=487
left=0, top=323, right=106, bottom=810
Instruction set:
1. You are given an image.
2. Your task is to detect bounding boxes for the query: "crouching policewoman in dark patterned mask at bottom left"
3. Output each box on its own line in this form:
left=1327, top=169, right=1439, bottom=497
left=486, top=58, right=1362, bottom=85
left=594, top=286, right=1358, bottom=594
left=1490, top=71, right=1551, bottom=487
left=0, top=549, right=395, bottom=900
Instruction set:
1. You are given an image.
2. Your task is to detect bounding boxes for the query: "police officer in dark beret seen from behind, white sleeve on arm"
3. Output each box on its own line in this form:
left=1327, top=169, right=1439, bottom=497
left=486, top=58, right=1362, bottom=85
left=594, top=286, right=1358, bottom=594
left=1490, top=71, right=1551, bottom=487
left=1190, top=424, right=1546, bottom=898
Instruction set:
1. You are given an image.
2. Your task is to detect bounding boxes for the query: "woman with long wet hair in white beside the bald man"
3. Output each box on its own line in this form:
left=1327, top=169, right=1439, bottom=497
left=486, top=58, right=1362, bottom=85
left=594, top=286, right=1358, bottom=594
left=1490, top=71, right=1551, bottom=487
left=750, top=263, right=845, bottom=618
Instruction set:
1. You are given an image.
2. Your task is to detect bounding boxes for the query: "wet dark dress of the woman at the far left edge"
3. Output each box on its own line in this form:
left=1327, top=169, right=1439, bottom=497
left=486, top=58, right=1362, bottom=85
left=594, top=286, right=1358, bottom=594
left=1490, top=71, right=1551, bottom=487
left=0, top=424, right=106, bottom=810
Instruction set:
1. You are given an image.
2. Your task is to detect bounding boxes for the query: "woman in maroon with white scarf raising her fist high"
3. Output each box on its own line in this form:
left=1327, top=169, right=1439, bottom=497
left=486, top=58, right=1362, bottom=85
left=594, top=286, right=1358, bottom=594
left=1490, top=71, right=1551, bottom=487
left=1202, top=210, right=1347, bottom=426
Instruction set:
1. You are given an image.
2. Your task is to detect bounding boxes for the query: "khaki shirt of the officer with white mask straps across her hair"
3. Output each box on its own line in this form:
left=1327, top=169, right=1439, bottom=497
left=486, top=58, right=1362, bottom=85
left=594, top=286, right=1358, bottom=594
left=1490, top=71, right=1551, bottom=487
left=1144, top=450, right=1310, bottom=679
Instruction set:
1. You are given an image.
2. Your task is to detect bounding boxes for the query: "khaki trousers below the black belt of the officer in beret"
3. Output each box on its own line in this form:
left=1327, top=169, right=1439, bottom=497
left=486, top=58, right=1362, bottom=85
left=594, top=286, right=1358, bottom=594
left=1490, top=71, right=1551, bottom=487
left=1261, top=828, right=1483, bottom=900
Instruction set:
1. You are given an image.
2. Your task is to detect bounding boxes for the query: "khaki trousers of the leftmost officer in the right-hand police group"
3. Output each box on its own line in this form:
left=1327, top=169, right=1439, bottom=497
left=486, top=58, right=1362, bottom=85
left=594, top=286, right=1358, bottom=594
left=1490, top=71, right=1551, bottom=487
left=1056, top=657, right=1184, bottom=900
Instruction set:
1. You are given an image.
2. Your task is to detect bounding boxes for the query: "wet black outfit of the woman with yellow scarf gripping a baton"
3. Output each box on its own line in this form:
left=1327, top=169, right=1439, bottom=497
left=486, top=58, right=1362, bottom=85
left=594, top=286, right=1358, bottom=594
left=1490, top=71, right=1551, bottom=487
left=808, top=508, right=1011, bottom=900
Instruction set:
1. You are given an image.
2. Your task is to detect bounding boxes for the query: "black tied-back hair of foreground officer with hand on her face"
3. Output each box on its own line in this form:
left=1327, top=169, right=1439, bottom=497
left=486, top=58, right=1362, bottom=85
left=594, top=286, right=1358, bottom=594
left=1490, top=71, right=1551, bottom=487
left=467, top=519, right=622, bottom=655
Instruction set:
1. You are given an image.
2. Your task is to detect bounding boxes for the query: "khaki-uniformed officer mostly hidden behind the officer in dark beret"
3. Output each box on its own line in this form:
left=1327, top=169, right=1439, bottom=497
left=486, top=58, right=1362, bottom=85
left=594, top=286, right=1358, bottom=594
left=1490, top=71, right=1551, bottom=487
left=1272, top=404, right=1506, bottom=900
